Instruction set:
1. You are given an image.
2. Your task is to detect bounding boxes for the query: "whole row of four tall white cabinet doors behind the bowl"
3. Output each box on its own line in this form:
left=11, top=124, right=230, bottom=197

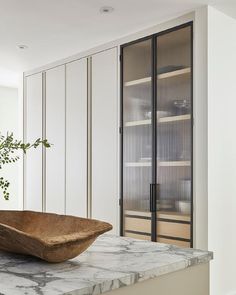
left=24, top=48, right=119, bottom=233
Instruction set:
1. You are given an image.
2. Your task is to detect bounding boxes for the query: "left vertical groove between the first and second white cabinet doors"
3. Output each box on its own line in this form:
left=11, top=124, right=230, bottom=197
left=42, top=72, right=46, bottom=212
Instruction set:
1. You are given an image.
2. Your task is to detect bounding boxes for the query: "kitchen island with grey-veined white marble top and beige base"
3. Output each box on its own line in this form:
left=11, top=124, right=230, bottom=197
left=0, top=235, right=213, bottom=295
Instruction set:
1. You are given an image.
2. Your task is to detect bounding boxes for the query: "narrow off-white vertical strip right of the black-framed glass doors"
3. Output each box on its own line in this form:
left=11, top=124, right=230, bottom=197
left=193, top=7, right=208, bottom=249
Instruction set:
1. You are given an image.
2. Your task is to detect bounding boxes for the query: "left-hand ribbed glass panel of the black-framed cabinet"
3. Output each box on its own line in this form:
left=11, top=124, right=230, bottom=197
left=123, top=39, right=152, bottom=240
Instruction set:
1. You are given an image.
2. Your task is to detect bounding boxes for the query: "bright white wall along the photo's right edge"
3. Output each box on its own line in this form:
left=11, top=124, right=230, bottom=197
left=208, top=7, right=236, bottom=295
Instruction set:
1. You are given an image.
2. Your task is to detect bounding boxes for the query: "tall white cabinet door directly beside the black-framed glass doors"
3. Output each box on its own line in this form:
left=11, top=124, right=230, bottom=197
left=91, top=48, right=118, bottom=233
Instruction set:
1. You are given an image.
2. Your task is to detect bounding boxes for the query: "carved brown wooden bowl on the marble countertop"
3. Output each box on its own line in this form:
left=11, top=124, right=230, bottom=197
left=0, top=210, right=112, bottom=262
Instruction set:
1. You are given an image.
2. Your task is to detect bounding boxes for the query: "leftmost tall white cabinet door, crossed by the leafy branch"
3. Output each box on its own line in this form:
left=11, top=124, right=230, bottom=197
left=24, top=73, right=43, bottom=211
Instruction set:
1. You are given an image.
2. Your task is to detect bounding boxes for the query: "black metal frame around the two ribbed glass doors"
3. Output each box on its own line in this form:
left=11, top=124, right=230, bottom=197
left=119, top=21, right=194, bottom=247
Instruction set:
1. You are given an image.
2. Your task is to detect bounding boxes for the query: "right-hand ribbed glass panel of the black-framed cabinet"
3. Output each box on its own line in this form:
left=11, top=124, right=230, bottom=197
left=156, top=26, right=192, bottom=247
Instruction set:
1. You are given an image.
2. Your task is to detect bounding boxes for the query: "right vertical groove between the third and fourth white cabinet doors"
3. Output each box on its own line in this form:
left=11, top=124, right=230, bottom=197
left=87, top=57, right=92, bottom=218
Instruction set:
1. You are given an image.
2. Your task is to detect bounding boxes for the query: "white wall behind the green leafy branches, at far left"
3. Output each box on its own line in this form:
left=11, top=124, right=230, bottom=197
left=0, top=86, right=21, bottom=210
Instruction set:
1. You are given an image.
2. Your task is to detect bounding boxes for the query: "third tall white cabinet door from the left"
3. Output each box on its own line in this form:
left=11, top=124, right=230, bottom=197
left=66, top=58, right=87, bottom=217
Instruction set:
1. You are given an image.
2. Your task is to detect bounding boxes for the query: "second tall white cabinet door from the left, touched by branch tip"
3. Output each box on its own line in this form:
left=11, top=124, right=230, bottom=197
left=45, top=65, right=65, bottom=214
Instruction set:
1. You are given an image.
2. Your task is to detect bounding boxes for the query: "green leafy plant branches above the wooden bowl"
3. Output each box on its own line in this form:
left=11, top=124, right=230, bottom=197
left=0, top=133, right=51, bottom=200
